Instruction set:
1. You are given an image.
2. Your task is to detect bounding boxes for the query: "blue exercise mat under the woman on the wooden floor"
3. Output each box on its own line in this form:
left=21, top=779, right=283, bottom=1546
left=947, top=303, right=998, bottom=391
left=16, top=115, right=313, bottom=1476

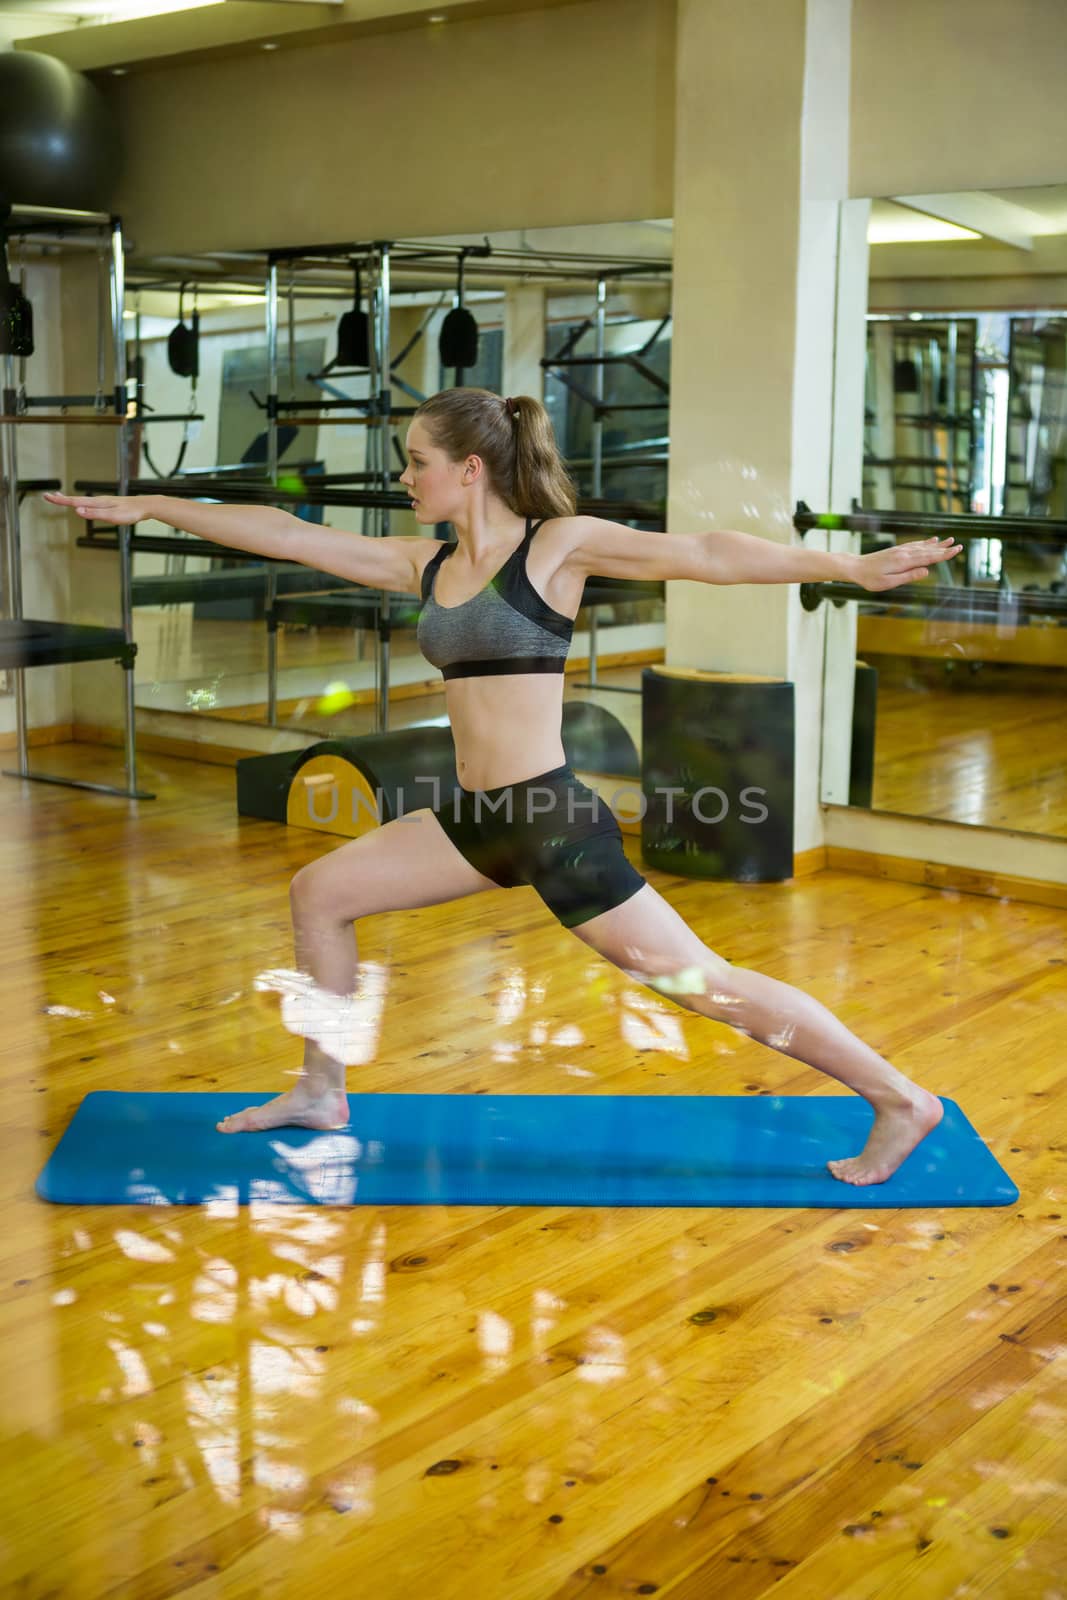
left=37, top=1091, right=1019, bottom=1210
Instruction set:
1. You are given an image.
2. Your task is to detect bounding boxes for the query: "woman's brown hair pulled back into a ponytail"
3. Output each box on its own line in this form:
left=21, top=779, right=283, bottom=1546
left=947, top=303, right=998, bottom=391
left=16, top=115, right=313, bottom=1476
left=414, top=389, right=576, bottom=517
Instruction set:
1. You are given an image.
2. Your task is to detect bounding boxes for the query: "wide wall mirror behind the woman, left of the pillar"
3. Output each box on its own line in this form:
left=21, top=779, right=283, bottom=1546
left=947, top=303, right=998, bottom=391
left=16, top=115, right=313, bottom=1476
left=126, top=222, right=672, bottom=742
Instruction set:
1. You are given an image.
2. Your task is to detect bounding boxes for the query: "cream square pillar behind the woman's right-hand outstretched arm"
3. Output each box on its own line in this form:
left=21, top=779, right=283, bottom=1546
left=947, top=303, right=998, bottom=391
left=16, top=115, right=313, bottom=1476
left=667, top=0, right=862, bottom=851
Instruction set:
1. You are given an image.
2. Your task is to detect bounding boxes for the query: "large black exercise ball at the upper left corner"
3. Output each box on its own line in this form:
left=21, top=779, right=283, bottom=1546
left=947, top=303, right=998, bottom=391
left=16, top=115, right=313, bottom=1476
left=0, top=50, right=120, bottom=211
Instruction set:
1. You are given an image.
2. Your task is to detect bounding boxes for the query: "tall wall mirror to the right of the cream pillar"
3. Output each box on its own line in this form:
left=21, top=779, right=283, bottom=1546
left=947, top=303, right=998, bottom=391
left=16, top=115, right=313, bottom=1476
left=824, top=187, right=1067, bottom=838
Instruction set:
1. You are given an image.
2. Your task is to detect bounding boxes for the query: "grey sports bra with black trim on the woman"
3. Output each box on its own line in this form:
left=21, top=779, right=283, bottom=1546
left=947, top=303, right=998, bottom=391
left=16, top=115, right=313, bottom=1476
left=418, top=517, right=574, bottom=678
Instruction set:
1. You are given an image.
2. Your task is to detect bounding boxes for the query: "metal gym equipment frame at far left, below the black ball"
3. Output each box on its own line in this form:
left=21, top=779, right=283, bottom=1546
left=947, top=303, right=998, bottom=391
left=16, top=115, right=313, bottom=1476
left=0, top=205, right=154, bottom=800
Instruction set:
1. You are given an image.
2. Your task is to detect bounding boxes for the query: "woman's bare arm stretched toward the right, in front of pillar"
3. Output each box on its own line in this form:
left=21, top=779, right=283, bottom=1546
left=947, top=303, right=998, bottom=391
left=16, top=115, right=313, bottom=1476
left=568, top=517, right=963, bottom=592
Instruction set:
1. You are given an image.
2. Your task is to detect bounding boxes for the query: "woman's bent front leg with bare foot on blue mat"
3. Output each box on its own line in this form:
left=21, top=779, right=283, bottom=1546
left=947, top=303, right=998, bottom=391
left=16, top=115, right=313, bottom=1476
left=218, top=810, right=498, bottom=1133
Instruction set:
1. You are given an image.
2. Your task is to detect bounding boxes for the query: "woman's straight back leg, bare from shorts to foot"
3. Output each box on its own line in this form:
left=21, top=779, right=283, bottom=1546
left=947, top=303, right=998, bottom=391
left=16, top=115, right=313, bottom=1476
left=573, top=883, right=944, bottom=1184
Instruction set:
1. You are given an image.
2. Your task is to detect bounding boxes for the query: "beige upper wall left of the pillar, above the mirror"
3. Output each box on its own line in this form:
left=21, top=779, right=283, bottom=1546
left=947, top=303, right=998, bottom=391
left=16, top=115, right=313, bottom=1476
left=107, top=0, right=673, bottom=253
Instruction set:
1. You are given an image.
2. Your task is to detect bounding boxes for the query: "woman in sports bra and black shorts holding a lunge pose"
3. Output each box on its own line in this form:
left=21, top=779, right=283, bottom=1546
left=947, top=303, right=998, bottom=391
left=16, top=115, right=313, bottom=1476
left=45, top=389, right=960, bottom=1184
